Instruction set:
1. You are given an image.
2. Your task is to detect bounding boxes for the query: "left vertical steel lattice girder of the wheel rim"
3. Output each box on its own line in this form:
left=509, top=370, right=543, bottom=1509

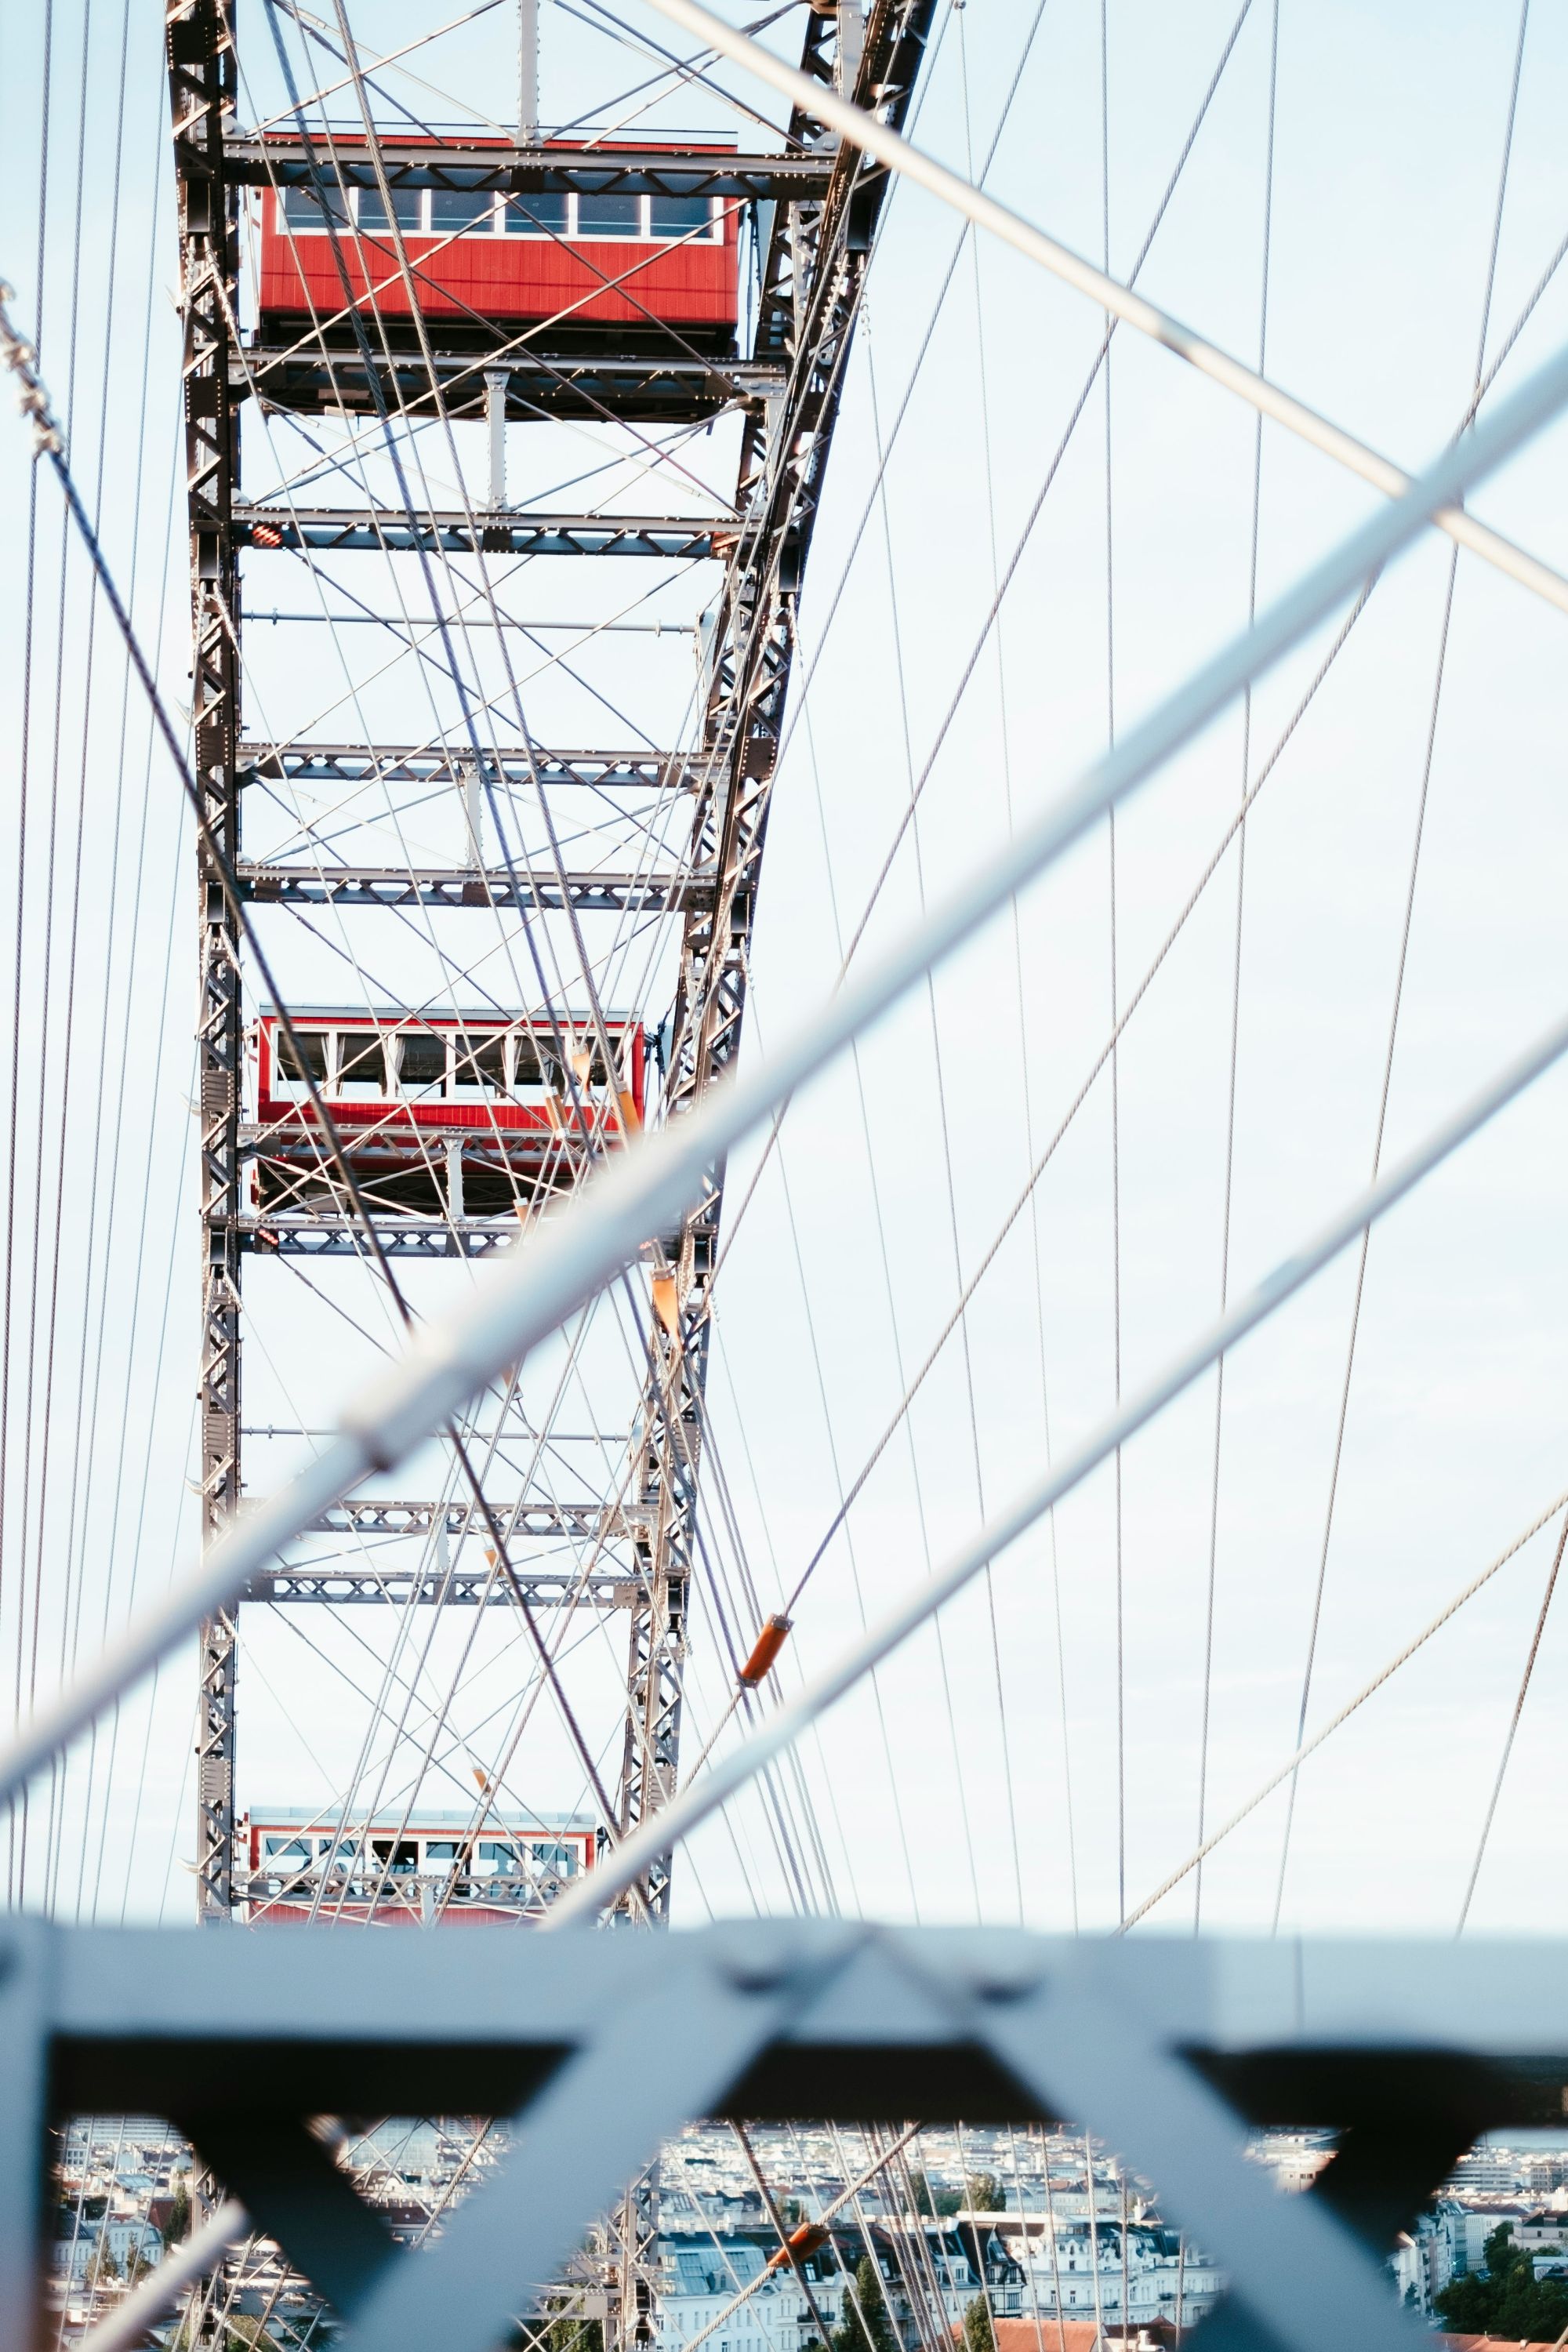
left=165, top=0, right=245, bottom=1919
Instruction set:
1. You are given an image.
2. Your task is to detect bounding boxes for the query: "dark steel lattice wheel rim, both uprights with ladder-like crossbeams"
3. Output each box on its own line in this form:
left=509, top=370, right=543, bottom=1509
left=167, top=0, right=933, bottom=2314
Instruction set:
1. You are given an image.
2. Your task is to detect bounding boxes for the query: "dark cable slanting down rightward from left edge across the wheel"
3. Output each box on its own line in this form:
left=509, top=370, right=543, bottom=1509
left=0, top=287, right=648, bottom=1910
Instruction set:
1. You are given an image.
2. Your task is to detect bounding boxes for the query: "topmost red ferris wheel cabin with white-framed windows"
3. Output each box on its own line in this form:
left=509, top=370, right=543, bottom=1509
left=259, top=139, right=741, bottom=355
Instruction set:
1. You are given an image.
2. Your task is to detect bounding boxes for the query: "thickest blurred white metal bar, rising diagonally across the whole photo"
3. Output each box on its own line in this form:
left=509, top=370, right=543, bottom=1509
left=0, top=310, right=1568, bottom=1816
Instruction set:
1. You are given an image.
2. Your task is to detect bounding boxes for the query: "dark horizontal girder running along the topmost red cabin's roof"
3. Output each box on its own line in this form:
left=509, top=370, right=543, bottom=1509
left=223, top=132, right=837, bottom=205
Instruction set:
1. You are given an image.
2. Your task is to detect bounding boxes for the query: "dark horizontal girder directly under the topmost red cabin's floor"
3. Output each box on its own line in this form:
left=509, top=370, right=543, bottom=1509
left=243, top=343, right=785, bottom=426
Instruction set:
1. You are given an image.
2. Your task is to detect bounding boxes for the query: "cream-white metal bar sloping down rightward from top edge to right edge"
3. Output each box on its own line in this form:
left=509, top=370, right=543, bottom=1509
left=634, top=0, right=1568, bottom=612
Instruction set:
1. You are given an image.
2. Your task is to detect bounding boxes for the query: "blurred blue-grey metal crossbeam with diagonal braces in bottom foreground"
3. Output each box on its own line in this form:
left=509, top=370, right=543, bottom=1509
left=24, top=1919, right=1568, bottom=2352
